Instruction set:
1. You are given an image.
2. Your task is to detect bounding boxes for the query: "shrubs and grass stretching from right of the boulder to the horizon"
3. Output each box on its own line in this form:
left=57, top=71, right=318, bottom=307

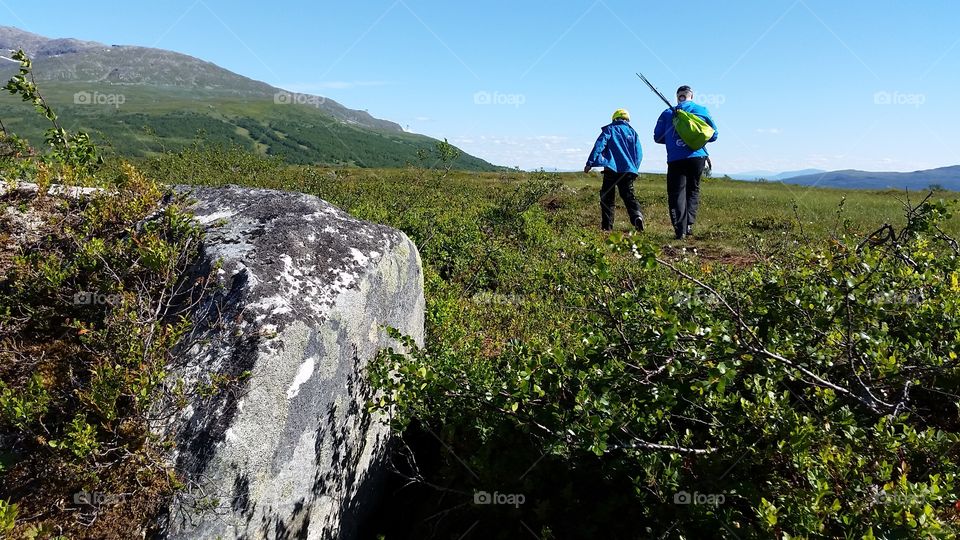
left=148, top=141, right=960, bottom=539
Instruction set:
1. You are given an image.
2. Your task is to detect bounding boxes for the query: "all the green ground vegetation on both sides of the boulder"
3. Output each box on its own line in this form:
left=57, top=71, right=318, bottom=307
left=0, top=137, right=960, bottom=540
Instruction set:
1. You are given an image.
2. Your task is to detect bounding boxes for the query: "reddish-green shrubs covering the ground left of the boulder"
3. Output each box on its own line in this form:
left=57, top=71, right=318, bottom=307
left=0, top=52, right=200, bottom=538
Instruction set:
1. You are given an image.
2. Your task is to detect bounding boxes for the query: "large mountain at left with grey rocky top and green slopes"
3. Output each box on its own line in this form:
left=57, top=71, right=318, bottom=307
left=0, top=26, right=498, bottom=170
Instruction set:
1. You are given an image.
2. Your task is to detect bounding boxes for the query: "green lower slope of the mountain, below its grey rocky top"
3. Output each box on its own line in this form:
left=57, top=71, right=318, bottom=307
left=0, top=82, right=496, bottom=170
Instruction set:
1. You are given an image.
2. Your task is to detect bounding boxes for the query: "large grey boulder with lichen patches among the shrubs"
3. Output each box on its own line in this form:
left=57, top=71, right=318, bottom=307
left=156, top=186, right=424, bottom=539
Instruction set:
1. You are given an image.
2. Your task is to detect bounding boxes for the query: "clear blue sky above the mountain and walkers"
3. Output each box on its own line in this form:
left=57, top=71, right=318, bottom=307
left=0, top=0, right=960, bottom=173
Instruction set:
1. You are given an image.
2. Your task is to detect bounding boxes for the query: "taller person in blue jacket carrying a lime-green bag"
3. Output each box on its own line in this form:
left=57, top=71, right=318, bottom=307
left=653, top=85, right=718, bottom=240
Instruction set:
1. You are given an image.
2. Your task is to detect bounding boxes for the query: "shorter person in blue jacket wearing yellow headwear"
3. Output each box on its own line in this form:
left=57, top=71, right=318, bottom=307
left=583, top=109, right=643, bottom=231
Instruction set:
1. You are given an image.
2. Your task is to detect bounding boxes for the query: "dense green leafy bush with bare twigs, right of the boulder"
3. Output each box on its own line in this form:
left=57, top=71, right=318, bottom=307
left=371, top=196, right=960, bottom=539
